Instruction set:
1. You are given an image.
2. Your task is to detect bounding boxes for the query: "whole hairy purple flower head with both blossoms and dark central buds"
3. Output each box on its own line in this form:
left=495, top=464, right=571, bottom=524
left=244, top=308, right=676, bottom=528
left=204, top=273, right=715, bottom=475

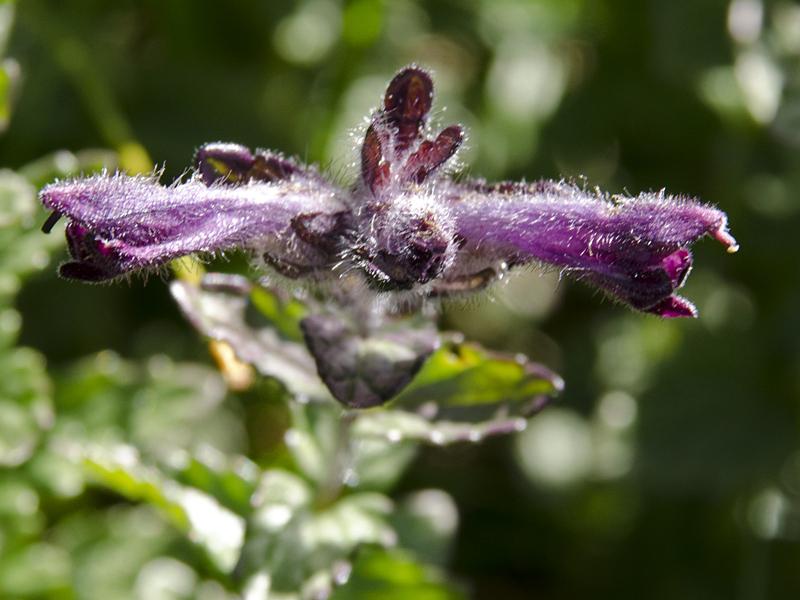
left=41, top=66, right=737, bottom=317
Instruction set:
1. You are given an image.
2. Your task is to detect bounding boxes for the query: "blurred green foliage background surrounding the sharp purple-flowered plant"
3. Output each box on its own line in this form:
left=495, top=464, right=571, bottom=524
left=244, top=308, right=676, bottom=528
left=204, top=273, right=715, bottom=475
left=0, top=0, right=800, bottom=600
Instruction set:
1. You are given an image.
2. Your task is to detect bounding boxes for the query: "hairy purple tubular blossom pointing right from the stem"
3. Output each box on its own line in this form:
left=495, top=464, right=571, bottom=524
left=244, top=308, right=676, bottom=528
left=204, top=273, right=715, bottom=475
left=438, top=181, right=738, bottom=317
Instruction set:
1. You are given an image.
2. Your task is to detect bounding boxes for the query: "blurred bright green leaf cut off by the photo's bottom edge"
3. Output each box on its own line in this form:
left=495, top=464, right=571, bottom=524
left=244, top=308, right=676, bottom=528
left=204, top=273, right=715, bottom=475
left=331, top=548, right=466, bottom=600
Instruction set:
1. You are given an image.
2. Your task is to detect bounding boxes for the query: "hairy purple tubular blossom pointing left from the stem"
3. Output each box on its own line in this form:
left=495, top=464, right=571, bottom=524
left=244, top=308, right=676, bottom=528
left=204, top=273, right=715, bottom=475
left=41, top=151, right=344, bottom=281
